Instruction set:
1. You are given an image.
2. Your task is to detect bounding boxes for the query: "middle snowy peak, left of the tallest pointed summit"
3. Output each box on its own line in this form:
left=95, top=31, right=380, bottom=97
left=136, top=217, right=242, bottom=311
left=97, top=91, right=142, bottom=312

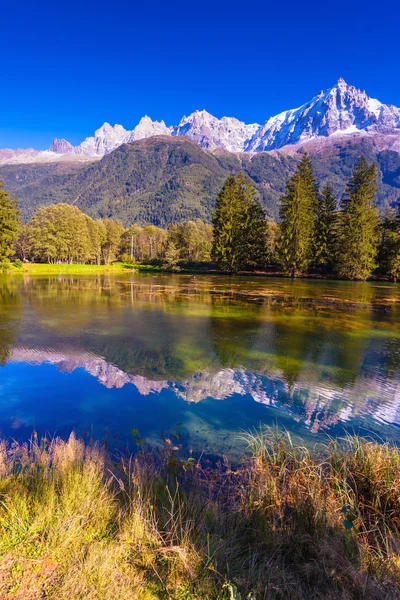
left=172, top=110, right=260, bottom=152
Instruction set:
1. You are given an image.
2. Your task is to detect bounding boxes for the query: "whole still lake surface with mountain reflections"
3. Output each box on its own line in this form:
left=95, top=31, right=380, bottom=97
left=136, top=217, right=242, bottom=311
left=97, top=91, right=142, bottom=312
left=0, top=274, right=400, bottom=456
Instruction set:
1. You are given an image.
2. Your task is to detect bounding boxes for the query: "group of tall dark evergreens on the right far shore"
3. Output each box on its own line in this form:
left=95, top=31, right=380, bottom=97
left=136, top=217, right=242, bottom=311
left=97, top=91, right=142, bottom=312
left=212, top=154, right=400, bottom=280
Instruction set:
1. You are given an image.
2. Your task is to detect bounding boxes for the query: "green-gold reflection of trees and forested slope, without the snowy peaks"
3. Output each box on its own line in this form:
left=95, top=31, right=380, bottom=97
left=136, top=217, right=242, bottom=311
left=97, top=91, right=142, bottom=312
left=6, top=275, right=400, bottom=394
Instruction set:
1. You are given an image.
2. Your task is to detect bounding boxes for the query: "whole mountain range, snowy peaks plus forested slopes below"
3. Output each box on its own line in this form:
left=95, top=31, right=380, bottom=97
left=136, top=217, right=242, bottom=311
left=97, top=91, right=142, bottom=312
left=0, top=79, right=400, bottom=225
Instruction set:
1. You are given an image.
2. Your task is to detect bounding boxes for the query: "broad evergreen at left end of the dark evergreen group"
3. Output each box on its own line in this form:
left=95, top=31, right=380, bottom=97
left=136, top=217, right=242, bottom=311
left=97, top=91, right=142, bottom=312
left=212, top=173, right=267, bottom=273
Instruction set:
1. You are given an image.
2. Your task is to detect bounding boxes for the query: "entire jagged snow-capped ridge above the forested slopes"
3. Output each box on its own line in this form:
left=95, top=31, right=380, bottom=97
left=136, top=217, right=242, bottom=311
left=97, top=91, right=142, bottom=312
left=0, top=79, right=400, bottom=164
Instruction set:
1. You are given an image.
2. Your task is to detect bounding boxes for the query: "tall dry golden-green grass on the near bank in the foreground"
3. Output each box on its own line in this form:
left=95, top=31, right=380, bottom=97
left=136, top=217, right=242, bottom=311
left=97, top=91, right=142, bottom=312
left=0, top=434, right=400, bottom=600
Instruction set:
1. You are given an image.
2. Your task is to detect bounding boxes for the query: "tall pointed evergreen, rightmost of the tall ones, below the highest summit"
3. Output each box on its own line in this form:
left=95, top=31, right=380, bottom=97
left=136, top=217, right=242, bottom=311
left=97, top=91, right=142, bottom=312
left=337, top=157, right=379, bottom=281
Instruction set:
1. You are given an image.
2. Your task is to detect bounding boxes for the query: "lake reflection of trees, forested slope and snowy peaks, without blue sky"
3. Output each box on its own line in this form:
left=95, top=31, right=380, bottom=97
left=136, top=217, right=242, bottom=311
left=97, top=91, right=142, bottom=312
left=5, top=276, right=400, bottom=438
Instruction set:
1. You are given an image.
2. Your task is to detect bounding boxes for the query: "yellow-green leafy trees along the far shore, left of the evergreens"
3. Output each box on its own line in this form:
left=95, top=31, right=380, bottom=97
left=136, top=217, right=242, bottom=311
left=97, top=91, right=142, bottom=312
left=0, top=193, right=212, bottom=268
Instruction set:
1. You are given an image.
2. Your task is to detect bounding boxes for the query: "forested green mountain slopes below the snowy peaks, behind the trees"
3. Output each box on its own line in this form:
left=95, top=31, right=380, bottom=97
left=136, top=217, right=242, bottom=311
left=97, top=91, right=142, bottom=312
left=0, top=136, right=400, bottom=226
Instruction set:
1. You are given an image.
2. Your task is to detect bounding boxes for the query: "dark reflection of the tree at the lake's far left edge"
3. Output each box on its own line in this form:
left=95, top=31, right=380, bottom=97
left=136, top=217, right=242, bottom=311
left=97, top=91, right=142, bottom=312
left=0, top=278, right=20, bottom=366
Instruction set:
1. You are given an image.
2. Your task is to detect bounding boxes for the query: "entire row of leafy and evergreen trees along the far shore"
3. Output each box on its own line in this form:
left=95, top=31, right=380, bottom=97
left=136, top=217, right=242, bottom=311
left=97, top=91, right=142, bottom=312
left=0, top=154, right=400, bottom=280
